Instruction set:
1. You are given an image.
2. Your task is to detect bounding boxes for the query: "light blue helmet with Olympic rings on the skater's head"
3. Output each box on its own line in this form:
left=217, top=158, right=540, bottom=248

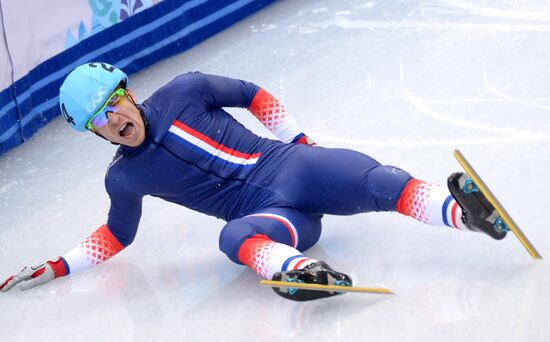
left=59, top=62, right=128, bottom=131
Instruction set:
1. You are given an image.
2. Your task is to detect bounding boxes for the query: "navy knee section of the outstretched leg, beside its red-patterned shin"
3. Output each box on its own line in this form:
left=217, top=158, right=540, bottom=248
left=367, top=165, right=412, bottom=211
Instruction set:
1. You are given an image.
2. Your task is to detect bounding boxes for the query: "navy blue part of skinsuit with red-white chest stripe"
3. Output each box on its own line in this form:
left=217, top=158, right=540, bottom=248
left=105, top=73, right=411, bottom=263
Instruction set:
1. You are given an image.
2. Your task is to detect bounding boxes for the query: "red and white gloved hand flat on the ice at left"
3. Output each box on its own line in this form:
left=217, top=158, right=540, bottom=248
left=0, top=258, right=67, bottom=292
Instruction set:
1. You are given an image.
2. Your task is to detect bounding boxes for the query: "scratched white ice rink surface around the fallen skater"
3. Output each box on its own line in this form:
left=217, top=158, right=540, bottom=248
left=0, top=0, right=550, bottom=342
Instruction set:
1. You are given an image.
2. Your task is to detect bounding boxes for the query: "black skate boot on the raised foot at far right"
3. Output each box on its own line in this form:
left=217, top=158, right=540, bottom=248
left=447, top=172, right=508, bottom=240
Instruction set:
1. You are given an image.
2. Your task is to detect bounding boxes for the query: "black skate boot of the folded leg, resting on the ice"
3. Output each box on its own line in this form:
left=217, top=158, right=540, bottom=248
left=272, top=261, right=352, bottom=302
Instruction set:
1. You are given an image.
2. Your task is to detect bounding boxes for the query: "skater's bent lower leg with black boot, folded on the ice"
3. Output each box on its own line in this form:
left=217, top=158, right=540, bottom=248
left=220, top=208, right=352, bottom=301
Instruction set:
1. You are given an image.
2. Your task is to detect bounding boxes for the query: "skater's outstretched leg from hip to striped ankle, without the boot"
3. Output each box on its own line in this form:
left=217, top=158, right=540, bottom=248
left=274, top=146, right=465, bottom=229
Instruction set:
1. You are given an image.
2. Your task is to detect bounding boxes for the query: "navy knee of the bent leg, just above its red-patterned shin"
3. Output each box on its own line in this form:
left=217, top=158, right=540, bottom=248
left=219, top=219, right=258, bottom=265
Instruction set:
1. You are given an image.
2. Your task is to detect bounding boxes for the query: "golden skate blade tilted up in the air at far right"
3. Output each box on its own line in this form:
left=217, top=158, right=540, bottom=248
left=454, top=150, right=542, bottom=259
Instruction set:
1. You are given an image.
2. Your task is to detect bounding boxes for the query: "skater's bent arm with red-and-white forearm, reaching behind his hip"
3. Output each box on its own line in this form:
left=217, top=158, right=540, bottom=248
left=195, top=73, right=315, bottom=145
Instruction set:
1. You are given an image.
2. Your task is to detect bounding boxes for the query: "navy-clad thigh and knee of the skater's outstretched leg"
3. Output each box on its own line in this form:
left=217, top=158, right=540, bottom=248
left=270, top=146, right=411, bottom=215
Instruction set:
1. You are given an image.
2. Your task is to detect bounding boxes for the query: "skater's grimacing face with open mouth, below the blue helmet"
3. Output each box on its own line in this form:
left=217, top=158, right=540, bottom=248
left=92, top=89, right=145, bottom=147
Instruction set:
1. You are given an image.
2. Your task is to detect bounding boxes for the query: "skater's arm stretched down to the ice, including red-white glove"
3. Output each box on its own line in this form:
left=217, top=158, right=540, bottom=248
left=0, top=166, right=142, bottom=292
